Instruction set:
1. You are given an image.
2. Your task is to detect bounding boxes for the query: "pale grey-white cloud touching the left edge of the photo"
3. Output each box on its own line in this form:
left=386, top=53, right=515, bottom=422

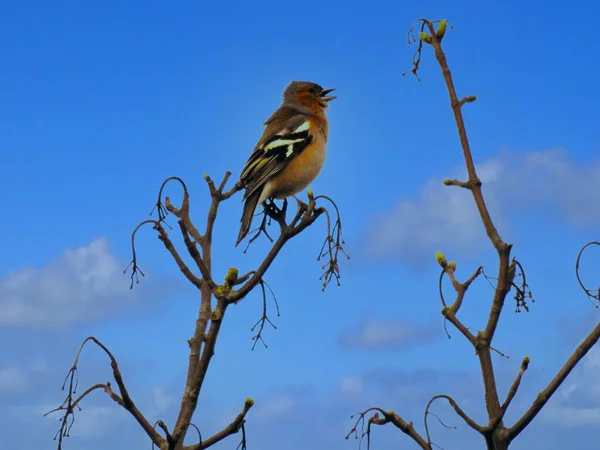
left=0, top=238, right=168, bottom=327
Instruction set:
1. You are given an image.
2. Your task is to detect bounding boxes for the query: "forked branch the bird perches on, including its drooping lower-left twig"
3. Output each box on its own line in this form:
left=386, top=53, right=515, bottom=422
left=55, top=172, right=343, bottom=450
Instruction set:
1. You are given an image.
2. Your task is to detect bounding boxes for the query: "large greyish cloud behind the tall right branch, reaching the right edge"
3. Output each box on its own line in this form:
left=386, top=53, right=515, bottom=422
left=367, top=149, right=600, bottom=261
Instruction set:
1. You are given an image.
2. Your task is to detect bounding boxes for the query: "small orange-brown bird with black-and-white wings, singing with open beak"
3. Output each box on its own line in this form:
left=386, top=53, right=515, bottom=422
left=235, top=81, right=337, bottom=247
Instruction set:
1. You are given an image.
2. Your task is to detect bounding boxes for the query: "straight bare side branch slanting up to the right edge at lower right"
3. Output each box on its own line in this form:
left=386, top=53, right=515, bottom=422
left=508, top=323, right=600, bottom=441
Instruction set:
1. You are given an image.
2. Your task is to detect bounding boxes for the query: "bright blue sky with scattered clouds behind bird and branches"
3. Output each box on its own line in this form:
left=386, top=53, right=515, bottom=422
left=0, top=1, right=600, bottom=450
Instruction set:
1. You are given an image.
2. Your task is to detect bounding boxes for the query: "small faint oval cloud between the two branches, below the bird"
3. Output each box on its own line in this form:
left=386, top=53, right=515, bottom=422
left=338, top=317, right=439, bottom=350
